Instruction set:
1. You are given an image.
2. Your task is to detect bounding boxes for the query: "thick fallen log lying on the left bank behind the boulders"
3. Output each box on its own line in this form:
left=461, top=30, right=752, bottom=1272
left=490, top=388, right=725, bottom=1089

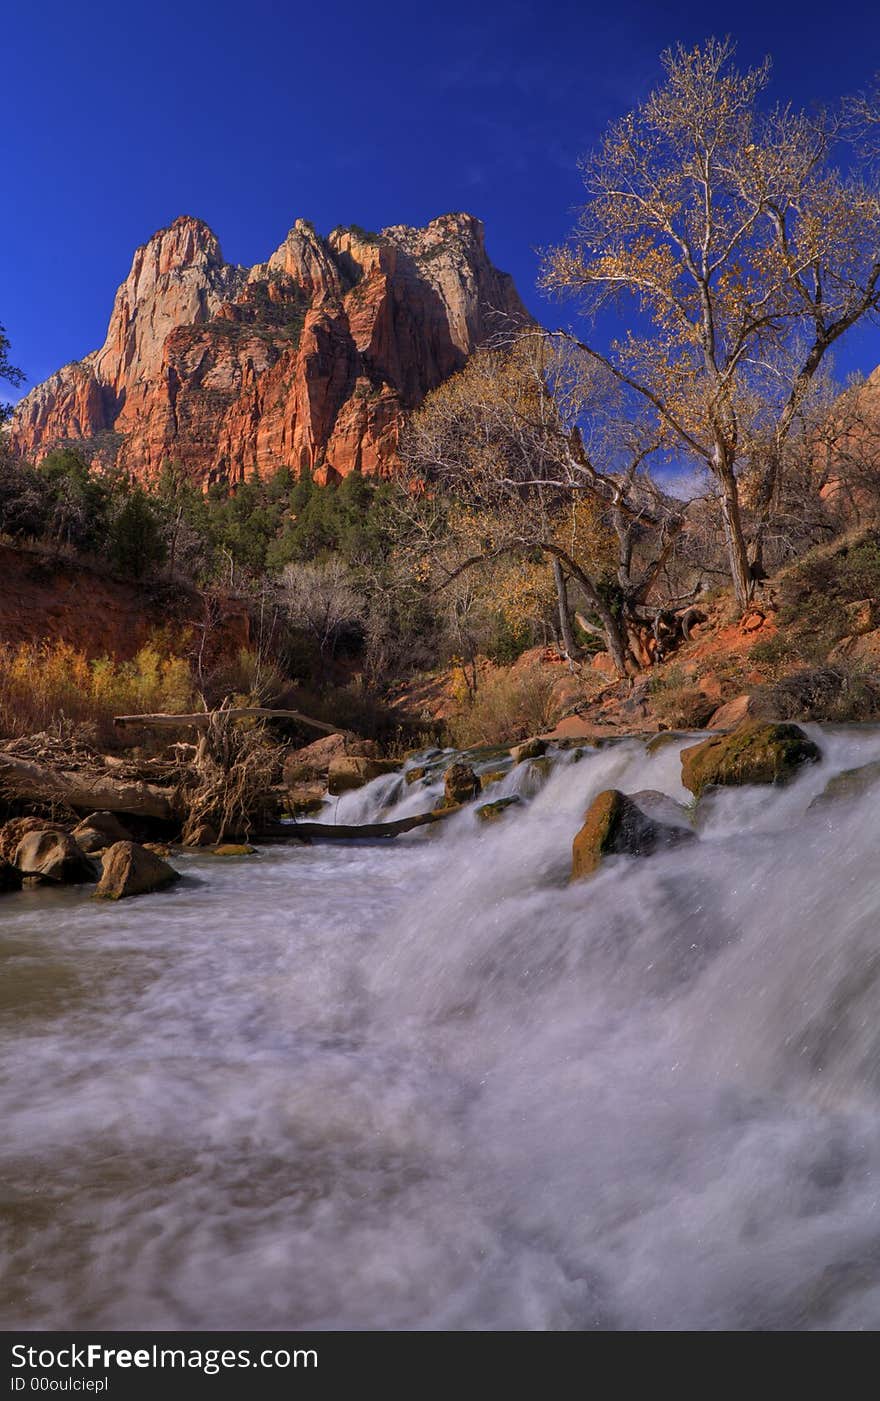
left=0, top=754, right=177, bottom=822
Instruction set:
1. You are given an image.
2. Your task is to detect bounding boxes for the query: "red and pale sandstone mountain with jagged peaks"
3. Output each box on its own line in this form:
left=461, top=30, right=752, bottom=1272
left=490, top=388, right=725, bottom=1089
left=11, top=214, right=527, bottom=482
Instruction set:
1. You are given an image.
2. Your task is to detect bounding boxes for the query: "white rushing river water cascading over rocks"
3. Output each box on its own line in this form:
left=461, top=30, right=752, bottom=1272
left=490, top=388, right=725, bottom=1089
left=0, top=727, right=880, bottom=1330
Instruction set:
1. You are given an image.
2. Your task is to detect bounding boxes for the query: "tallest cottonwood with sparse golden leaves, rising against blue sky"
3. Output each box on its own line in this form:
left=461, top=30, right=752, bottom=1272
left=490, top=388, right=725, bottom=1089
left=542, top=39, right=880, bottom=605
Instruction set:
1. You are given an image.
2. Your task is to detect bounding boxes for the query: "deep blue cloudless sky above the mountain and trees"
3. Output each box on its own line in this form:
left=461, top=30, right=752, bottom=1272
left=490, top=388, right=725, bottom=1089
left=0, top=0, right=880, bottom=395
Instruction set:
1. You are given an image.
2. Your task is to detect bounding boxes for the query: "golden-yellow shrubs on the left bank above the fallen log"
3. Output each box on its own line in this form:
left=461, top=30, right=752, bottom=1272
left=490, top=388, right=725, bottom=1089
left=0, top=642, right=195, bottom=740
